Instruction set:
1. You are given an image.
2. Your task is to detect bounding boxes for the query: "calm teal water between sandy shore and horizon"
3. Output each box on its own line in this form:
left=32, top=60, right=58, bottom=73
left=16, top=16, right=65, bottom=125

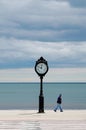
left=0, top=83, right=86, bottom=109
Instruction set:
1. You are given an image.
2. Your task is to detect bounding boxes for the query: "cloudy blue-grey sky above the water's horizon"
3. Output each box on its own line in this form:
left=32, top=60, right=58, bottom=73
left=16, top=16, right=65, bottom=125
left=0, top=0, right=86, bottom=82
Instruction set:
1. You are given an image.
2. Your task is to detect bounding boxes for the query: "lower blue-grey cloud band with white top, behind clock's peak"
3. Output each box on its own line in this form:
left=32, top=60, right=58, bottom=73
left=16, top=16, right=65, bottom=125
left=0, top=38, right=86, bottom=68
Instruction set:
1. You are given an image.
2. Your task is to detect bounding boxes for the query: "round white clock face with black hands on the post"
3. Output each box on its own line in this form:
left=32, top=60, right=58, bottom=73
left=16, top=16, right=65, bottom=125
left=36, top=63, right=47, bottom=74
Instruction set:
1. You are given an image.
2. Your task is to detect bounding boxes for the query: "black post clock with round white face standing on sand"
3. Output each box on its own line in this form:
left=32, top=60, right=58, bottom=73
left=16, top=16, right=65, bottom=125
left=35, top=57, right=49, bottom=113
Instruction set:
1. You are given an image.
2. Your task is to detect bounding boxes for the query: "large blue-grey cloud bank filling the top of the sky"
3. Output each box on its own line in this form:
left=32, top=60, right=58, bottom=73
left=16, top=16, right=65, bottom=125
left=0, top=0, right=86, bottom=41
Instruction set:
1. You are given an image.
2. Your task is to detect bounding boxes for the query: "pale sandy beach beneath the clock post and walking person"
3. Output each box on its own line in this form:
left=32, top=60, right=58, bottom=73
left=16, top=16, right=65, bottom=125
left=0, top=110, right=86, bottom=130
